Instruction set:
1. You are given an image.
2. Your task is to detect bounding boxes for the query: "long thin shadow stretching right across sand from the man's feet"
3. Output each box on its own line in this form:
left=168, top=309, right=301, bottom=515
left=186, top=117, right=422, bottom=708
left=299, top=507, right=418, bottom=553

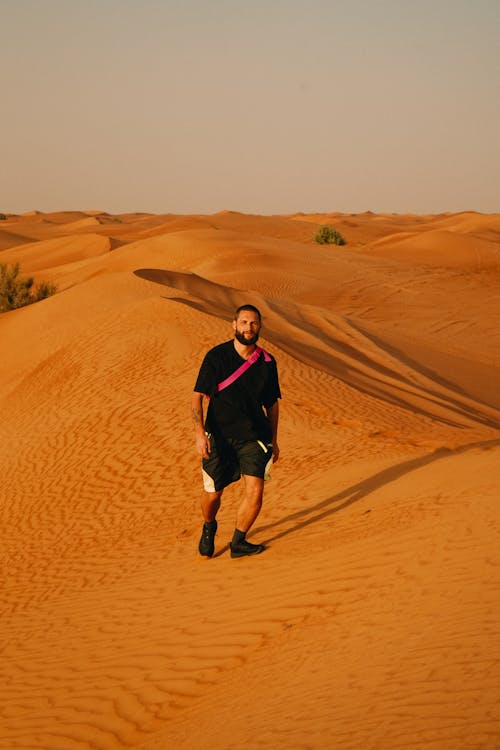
left=252, top=440, right=500, bottom=546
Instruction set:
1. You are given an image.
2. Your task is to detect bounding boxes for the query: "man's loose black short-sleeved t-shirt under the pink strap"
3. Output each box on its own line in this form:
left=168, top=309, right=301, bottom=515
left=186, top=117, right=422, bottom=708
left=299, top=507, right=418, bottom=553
left=194, top=340, right=281, bottom=441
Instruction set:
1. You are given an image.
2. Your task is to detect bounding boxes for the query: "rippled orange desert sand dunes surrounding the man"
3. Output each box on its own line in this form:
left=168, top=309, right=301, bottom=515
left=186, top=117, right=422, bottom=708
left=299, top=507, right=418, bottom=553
left=0, top=210, right=500, bottom=750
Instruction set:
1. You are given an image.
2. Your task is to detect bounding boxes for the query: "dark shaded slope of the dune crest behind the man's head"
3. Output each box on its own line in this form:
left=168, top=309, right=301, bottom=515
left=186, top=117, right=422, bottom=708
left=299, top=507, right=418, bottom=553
left=135, top=269, right=500, bottom=428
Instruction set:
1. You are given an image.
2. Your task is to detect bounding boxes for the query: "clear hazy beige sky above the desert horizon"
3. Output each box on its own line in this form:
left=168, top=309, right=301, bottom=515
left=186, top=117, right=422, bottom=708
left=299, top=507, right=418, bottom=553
left=0, top=0, right=500, bottom=214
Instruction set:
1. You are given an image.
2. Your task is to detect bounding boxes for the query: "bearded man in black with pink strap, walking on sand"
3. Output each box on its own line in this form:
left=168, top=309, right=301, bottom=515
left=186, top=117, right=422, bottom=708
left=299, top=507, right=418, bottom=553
left=192, top=305, right=281, bottom=557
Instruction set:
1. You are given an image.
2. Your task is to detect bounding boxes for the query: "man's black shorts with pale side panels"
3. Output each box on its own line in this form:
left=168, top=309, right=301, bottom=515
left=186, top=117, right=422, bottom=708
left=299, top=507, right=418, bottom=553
left=202, top=435, right=273, bottom=492
